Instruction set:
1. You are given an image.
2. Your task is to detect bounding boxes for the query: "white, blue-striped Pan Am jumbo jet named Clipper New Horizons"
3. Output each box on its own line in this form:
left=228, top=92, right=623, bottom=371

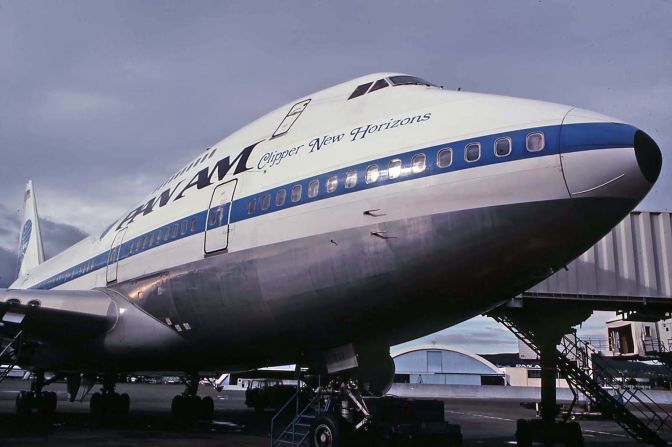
left=0, top=73, right=662, bottom=440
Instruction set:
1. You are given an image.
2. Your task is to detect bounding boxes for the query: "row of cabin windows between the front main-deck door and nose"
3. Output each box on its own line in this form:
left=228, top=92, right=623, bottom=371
left=247, top=132, right=544, bottom=214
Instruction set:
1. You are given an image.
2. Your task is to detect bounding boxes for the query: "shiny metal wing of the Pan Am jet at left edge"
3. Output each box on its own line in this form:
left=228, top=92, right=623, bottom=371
left=0, top=289, right=118, bottom=342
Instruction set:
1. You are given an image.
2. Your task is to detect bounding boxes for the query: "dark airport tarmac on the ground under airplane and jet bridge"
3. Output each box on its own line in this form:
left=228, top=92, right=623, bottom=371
left=0, top=379, right=664, bottom=447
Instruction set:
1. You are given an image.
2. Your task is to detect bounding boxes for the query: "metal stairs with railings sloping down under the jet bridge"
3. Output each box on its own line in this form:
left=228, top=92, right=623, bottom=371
left=494, top=315, right=672, bottom=445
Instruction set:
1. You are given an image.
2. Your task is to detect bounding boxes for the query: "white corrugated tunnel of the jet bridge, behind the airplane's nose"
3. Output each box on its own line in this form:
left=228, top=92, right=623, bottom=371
left=510, top=211, right=672, bottom=321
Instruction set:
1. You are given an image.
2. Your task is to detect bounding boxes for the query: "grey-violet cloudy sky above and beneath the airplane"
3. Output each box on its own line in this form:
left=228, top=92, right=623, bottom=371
left=0, top=0, right=672, bottom=352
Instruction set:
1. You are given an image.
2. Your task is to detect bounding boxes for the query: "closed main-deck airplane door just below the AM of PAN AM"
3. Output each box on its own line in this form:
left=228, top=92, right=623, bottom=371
left=205, top=179, right=238, bottom=253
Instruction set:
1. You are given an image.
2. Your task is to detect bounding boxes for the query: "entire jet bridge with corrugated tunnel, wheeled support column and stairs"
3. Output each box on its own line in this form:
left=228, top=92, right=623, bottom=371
left=489, top=211, right=672, bottom=445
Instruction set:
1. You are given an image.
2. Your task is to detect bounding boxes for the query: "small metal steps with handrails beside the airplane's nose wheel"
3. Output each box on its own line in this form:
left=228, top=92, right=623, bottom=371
left=271, top=387, right=331, bottom=447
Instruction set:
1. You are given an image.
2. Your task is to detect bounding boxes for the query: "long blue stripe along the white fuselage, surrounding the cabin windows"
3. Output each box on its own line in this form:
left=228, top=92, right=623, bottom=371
left=31, top=123, right=637, bottom=289
